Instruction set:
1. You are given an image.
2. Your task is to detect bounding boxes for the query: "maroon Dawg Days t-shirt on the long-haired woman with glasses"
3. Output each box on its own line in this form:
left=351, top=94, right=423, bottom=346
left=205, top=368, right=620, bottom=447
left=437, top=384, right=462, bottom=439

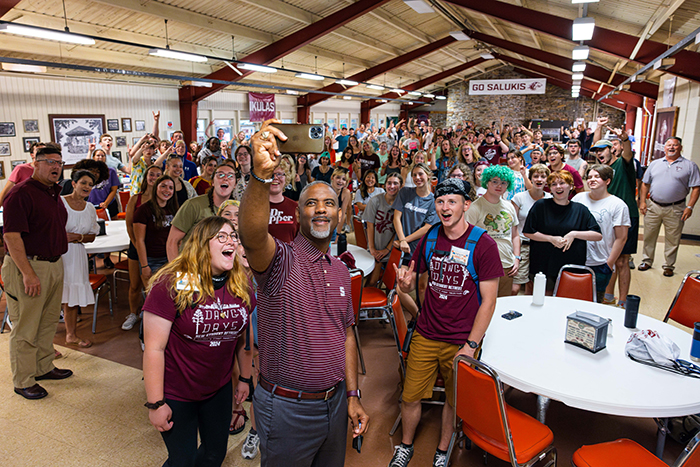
left=143, top=276, right=255, bottom=402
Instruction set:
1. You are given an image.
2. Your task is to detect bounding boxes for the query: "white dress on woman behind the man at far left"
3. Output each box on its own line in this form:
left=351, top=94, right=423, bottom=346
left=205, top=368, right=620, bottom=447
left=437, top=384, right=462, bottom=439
left=61, top=198, right=100, bottom=306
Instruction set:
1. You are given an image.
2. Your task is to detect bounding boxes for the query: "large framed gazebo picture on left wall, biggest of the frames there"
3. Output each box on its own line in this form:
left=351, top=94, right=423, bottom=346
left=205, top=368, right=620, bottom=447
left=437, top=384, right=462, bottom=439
left=48, top=115, right=106, bottom=165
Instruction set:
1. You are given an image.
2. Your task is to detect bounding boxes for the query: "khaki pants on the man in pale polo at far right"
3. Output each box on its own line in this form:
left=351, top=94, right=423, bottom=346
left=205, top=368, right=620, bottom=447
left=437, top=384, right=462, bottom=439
left=642, top=199, right=685, bottom=269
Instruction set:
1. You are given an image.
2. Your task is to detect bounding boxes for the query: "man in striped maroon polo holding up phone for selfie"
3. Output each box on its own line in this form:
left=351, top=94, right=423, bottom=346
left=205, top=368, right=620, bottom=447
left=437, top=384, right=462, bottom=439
left=239, top=120, right=369, bottom=467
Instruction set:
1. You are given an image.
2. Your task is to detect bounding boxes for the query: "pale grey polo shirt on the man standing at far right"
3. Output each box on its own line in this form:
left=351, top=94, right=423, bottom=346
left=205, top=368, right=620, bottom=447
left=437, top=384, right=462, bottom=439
left=642, top=156, right=700, bottom=203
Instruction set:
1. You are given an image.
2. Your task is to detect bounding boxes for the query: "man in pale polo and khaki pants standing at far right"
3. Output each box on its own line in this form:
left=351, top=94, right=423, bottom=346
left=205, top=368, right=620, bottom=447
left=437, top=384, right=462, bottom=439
left=639, top=136, right=700, bottom=277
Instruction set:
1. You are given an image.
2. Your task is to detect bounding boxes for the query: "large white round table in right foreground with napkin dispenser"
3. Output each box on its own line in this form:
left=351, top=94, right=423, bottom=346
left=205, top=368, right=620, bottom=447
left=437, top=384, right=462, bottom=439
left=482, top=295, right=700, bottom=454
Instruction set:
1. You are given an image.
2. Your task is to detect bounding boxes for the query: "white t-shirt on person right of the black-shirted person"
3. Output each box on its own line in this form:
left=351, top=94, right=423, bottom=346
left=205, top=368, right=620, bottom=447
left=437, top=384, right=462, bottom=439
left=571, top=193, right=632, bottom=266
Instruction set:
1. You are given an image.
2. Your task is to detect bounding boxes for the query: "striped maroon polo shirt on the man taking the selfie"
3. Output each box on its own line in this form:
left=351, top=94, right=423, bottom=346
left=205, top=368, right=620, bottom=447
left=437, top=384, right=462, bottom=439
left=255, top=234, right=355, bottom=392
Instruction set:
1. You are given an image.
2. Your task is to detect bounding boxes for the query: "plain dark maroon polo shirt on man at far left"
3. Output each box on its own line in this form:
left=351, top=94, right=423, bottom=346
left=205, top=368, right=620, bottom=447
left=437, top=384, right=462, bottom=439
left=3, top=178, right=68, bottom=257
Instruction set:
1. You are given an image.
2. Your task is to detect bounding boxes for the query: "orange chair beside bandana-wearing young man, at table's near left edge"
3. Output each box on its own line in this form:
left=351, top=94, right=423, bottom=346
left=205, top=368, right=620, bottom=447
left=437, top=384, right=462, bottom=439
left=447, top=355, right=557, bottom=467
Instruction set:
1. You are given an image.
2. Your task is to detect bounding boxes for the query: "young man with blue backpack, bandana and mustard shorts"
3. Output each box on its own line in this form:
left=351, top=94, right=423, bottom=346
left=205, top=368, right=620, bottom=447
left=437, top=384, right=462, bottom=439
left=389, top=178, right=503, bottom=467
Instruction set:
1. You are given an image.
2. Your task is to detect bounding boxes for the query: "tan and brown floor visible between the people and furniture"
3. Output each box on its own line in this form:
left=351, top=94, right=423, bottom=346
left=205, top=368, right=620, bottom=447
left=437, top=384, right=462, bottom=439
left=0, top=236, right=700, bottom=467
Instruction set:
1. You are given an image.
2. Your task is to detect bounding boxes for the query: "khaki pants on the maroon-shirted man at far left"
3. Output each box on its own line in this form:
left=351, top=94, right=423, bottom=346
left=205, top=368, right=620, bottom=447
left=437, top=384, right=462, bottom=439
left=2, top=256, right=63, bottom=388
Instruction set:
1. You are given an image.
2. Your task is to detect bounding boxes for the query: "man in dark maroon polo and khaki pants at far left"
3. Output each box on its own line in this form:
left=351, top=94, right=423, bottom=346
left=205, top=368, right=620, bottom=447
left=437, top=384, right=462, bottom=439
left=2, top=143, right=73, bottom=399
